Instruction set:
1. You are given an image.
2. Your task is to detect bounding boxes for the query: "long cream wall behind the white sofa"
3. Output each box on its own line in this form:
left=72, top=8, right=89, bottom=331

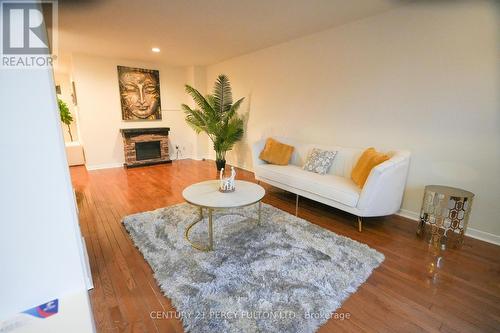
left=207, top=1, right=500, bottom=241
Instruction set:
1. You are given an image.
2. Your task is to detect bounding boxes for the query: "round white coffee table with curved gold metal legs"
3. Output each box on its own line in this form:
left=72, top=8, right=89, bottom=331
left=182, top=180, right=266, bottom=251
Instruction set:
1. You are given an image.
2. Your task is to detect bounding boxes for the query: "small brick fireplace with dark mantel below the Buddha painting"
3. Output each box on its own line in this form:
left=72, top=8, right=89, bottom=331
left=120, top=127, right=171, bottom=167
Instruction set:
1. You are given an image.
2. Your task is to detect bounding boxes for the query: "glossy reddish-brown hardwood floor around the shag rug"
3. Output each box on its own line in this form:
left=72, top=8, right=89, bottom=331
left=71, top=160, right=500, bottom=332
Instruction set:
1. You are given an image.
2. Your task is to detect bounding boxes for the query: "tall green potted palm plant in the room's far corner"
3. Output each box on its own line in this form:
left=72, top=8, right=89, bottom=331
left=182, top=75, right=244, bottom=171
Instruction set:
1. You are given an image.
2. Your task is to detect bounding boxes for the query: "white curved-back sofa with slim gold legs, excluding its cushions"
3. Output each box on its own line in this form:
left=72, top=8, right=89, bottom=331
left=252, top=137, right=410, bottom=231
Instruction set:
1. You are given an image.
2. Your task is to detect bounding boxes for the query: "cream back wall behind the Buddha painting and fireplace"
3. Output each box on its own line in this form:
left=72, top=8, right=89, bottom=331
left=72, top=54, right=196, bottom=169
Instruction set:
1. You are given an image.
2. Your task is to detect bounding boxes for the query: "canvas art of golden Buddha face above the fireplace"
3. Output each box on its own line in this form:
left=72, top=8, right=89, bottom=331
left=118, top=66, right=161, bottom=120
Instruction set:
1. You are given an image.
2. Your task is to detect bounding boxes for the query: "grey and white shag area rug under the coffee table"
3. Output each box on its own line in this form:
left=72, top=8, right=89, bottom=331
left=123, top=203, right=384, bottom=333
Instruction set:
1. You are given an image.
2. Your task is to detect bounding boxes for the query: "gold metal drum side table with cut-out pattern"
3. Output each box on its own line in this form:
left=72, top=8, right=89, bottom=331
left=417, top=185, right=474, bottom=249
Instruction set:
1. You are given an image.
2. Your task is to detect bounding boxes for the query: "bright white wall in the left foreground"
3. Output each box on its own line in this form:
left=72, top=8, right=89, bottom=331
left=0, top=63, right=93, bottom=332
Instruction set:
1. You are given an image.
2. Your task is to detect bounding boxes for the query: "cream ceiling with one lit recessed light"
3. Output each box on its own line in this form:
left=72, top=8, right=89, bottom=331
left=58, top=0, right=401, bottom=66
